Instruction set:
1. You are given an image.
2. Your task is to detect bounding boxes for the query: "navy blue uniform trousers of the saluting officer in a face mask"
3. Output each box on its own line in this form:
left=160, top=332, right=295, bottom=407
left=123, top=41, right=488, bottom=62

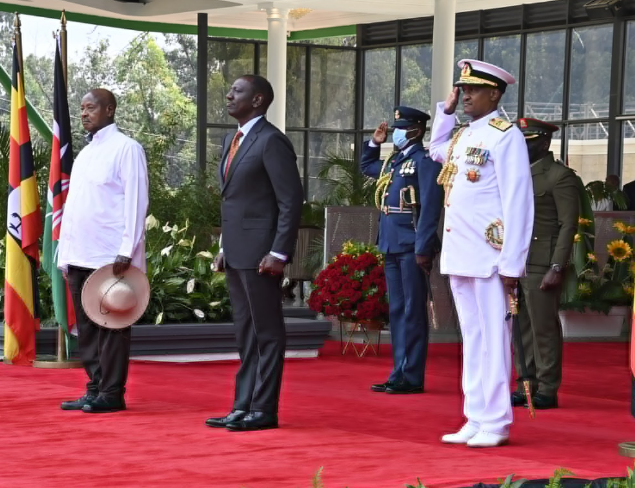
left=384, top=252, right=428, bottom=386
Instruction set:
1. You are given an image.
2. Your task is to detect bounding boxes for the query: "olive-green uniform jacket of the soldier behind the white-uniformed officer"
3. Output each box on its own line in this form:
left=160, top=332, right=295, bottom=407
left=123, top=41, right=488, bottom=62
left=527, top=154, right=580, bottom=273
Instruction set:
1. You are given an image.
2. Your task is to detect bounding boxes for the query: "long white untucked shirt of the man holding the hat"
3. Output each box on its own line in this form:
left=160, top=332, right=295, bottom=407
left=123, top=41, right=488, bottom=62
left=58, top=124, right=148, bottom=271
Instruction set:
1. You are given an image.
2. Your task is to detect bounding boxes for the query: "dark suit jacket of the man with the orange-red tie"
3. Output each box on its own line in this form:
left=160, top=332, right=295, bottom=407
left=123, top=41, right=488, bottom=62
left=218, top=117, right=304, bottom=269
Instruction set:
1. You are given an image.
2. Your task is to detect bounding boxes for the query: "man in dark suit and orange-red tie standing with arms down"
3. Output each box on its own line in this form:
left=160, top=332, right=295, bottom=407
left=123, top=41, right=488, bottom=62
left=206, top=75, right=304, bottom=430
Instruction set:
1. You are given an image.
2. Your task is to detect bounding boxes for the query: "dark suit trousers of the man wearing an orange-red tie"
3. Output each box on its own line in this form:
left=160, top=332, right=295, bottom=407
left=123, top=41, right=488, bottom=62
left=225, top=267, right=287, bottom=415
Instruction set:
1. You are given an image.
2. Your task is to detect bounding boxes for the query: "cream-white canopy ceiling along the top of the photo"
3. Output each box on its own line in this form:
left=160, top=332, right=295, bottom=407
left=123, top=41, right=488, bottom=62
left=2, top=0, right=557, bottom=31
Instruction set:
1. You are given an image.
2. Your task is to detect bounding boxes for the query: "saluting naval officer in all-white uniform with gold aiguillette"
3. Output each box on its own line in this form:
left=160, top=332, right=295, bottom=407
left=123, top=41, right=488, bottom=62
left=430, top=59, right=534, bottom=447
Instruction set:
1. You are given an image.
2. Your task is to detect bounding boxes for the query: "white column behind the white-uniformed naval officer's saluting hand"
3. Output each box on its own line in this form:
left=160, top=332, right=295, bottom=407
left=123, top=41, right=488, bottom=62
left=430, top=0, right=456, bottom=119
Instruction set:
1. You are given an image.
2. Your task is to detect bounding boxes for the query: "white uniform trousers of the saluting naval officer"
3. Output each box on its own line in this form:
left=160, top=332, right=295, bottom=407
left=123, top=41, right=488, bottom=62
left=450, top=274, right=513, bottom=435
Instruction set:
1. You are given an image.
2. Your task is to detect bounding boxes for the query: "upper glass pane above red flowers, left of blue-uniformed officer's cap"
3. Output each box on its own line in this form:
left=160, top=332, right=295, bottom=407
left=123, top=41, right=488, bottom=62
left=310, top=48, right=356, bottom=129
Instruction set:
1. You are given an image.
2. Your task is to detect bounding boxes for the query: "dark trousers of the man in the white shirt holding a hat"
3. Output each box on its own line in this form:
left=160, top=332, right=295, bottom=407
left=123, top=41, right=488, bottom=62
left=68, top=266, right=132, bottom=401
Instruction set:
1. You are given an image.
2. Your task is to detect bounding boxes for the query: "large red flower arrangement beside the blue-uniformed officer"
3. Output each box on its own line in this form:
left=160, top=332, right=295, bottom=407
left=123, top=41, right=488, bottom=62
left=309, top=241, right=388, bottom=322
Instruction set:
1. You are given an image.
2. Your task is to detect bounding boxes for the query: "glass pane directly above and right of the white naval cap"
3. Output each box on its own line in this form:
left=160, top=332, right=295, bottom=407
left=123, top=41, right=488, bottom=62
left=483, top=35, right=520, bottom=122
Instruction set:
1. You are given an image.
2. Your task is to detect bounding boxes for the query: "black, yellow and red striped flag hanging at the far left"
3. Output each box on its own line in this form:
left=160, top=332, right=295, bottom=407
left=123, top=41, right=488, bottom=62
left=4, top=44, right=42, bottom=364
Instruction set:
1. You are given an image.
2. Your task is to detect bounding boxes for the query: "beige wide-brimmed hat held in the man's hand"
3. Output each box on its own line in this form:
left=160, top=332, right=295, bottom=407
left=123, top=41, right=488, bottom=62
left=82, top=264, right=150, bottom=329
